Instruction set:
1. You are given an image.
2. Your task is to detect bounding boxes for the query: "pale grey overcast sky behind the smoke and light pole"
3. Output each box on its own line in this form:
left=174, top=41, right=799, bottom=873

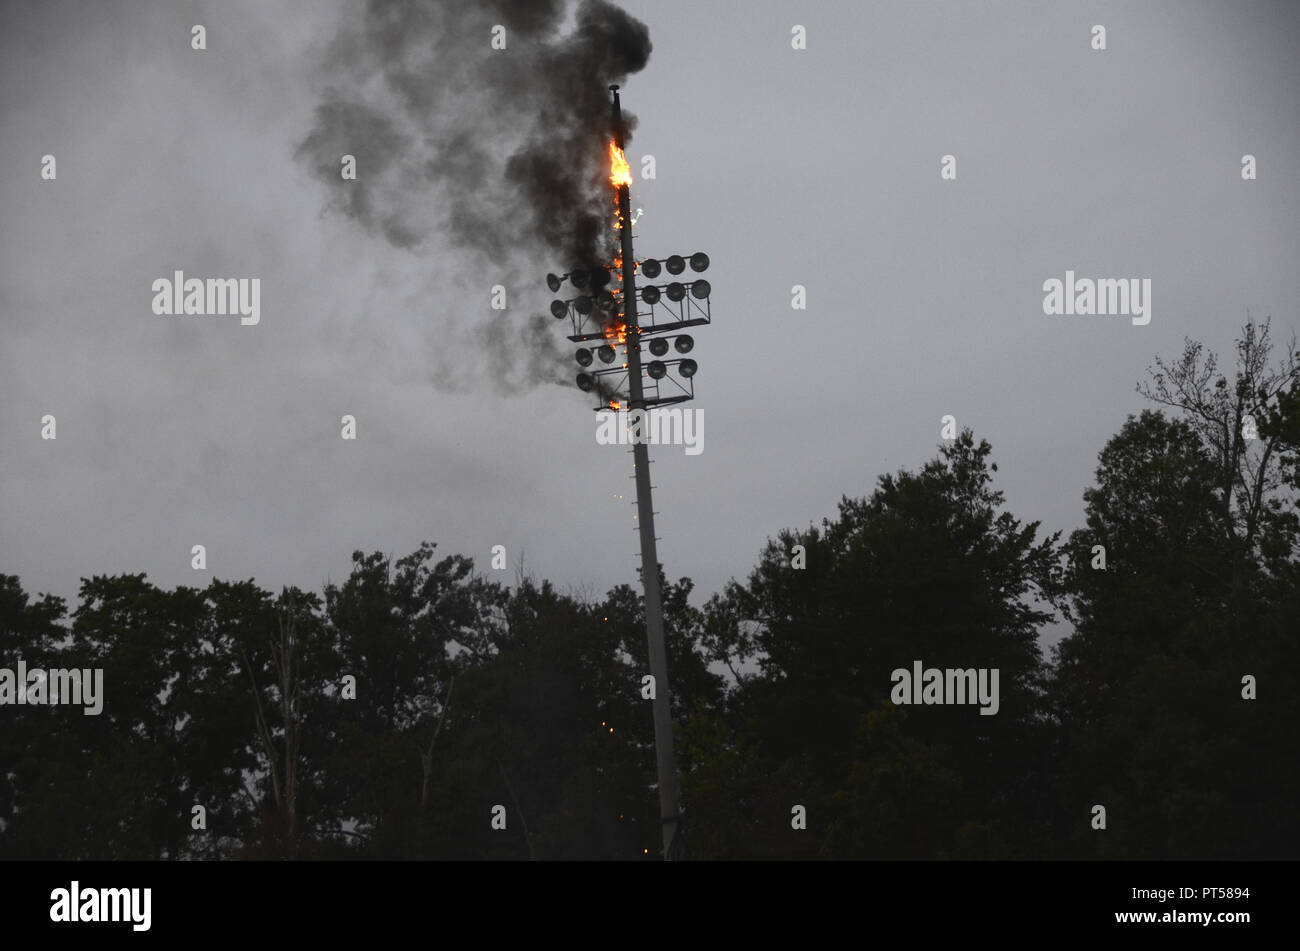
left=0, top=0, right=1300, bottom=646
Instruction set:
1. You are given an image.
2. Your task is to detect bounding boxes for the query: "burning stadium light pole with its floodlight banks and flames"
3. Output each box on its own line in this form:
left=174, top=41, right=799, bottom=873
left=546, top=86, right=712, bottom=861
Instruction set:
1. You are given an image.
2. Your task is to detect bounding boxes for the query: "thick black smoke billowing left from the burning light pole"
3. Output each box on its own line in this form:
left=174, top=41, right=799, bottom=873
left=298, top=0, right=650, bottom=383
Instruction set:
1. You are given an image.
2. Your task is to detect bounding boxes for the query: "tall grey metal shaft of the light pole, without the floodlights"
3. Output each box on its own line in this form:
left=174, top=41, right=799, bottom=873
left=610, top=86, right=683, bottom=861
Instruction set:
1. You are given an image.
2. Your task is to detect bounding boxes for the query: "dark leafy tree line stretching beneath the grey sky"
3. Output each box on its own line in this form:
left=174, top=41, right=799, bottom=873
left=0, top=322, right=1300, bottom=860
